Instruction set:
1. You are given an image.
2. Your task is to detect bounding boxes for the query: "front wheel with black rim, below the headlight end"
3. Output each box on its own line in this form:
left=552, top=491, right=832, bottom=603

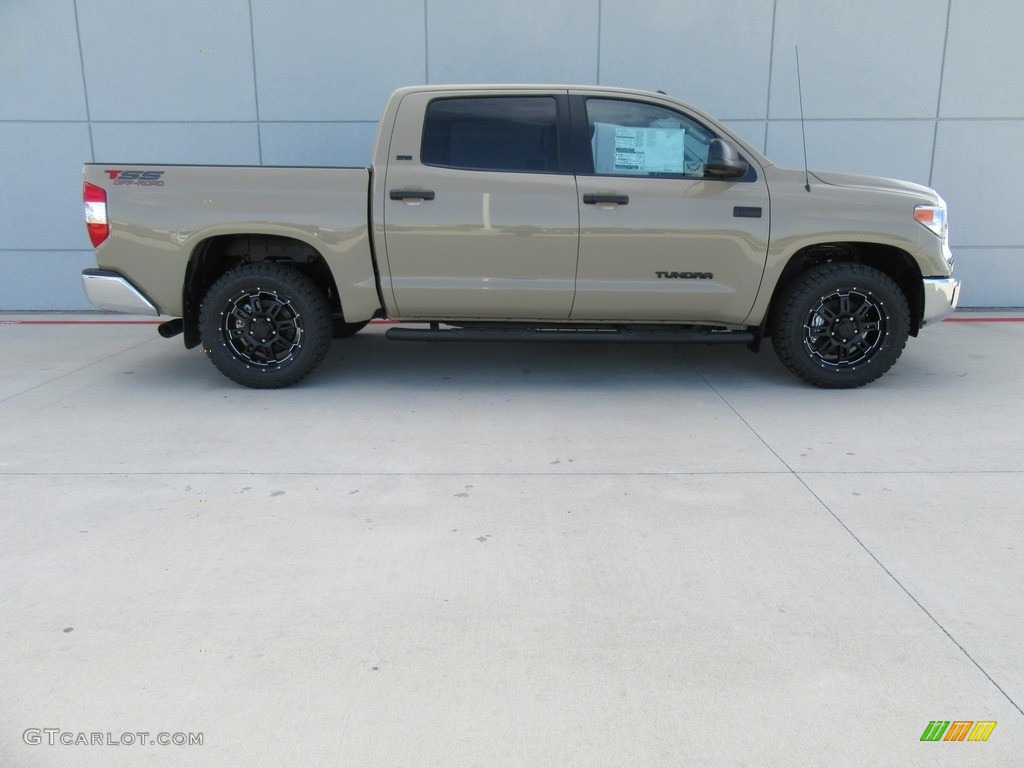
left=772, top=262, right=910, bottom=389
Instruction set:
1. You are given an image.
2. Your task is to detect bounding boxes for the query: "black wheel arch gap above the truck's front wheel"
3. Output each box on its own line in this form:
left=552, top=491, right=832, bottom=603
left=765, top=242, right=925, bottom=336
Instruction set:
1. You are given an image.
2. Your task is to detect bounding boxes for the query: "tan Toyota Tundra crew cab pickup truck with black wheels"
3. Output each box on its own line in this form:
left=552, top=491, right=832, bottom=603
left=83, top=85, right=959, bottom=388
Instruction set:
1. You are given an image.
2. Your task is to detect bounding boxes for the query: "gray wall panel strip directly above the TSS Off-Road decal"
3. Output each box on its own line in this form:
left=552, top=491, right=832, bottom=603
left=92, top=123, right=259, bottom=165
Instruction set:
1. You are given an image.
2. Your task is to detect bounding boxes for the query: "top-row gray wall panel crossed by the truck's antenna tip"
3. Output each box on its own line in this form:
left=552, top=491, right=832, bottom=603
left=771, top=0, right=946, bottom=119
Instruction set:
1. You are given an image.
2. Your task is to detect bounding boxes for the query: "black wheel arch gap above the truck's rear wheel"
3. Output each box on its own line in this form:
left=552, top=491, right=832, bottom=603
left=181, top=232, right=342, bottom=349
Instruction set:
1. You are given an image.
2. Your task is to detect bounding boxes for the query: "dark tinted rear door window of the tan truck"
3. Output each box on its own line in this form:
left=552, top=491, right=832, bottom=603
left=420, top=96, right=558, bottom=173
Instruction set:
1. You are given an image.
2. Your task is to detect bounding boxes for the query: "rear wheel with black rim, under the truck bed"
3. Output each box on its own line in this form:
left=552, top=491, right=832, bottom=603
left=199, top=261, right=332, bottom=389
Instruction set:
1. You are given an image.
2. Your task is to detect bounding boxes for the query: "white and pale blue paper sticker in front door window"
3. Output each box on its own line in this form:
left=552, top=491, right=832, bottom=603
left=593, top=123, right=686, bottom=175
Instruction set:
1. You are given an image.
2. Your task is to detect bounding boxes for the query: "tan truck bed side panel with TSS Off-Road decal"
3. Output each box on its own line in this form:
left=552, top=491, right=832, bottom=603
left=84, top=163, right=380, bottom=319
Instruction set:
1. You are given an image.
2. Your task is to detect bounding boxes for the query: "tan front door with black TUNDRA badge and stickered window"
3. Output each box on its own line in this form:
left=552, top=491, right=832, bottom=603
left=571, top=92, right=770, bottom=324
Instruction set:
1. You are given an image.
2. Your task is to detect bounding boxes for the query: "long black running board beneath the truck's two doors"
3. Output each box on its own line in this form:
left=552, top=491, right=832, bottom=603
left=384, top=328, right=754, bottom=344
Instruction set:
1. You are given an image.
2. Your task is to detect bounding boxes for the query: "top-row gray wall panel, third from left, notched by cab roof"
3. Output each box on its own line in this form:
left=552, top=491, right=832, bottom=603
left=253, top=0, right=426, bottom=121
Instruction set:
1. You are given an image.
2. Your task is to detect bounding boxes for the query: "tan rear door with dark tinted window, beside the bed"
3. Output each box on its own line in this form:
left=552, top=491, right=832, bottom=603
left=382, top=90, right=580, bottom=319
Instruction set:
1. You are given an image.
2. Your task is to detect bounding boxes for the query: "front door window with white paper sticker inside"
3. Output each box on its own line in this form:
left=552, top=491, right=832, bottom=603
left=587, top=98, right=716, bottom=178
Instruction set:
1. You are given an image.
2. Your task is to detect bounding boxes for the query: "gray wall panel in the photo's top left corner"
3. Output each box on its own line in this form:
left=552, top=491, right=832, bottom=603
left=0, top=0, right=87, bottom=120
